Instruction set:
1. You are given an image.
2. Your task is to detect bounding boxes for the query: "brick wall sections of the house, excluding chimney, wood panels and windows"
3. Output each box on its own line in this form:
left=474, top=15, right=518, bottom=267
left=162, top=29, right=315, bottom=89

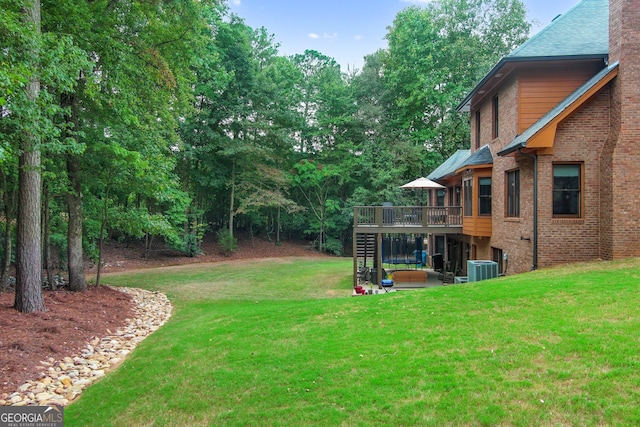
left=465, top=69, right=610, bottom=274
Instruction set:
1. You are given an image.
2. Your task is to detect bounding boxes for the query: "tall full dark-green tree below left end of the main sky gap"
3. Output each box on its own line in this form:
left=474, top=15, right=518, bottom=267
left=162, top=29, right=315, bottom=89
left=181, top=16, right=297, bottom=244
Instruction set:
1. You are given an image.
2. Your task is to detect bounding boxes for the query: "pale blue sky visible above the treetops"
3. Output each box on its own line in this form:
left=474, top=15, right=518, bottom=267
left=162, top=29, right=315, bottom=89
left=228, top=0, right=579, bottom=71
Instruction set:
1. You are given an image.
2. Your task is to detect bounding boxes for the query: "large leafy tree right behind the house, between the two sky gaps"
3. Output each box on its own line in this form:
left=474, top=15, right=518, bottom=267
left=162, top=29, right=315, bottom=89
left=385, top=0, right=529, bottom=164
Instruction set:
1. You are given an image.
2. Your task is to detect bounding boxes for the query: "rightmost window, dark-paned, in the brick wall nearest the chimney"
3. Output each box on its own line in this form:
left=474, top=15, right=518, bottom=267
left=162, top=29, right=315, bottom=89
left=553, top=164, right=582, bottom=218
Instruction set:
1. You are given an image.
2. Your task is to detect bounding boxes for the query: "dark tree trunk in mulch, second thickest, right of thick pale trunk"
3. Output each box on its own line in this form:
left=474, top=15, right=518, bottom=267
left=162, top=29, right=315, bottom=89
left=67, top=154, right=87, bottom=292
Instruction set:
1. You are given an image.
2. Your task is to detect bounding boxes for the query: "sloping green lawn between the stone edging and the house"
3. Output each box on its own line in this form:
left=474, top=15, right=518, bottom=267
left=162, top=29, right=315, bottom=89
left=65, top=259, right=640, bottom=426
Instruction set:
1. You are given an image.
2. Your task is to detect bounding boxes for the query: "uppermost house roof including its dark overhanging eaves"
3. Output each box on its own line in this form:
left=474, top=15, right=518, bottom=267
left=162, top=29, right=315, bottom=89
left=457, top=0, right=609, bottom=111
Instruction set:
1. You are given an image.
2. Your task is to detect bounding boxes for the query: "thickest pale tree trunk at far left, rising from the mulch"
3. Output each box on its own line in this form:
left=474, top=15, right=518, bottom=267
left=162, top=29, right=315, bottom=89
left=13, top=0, right=45, bottom=313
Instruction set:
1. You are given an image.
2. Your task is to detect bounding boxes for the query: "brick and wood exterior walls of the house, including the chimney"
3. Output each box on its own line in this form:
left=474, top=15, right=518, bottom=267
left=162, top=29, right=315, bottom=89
left=450, top=0, right=640, bottom=274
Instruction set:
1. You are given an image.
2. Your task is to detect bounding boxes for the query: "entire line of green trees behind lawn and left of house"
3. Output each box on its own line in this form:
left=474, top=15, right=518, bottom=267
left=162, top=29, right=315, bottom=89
left=0, top=0, right=529, bottom=311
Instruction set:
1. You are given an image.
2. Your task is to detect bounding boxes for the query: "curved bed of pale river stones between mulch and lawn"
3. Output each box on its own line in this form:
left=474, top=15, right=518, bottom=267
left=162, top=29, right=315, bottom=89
left=0, top=288, right=173, bottom=406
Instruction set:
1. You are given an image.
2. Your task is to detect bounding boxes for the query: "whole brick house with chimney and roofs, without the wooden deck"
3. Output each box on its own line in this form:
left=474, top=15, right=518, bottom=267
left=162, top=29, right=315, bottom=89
left=428, top=0, right=640, bottom=274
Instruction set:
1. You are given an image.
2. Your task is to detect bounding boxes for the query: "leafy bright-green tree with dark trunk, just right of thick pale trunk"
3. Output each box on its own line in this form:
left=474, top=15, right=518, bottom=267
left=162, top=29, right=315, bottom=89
left=37, top=0, right=217, bottom=291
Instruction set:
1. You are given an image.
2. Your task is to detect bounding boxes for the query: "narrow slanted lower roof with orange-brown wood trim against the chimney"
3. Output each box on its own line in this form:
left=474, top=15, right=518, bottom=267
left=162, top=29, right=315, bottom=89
left=498, top=62, right=618, bottom=156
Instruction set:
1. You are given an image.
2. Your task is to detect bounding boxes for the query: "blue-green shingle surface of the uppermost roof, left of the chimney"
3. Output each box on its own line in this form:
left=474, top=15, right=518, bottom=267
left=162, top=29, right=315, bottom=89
left=507, top=0, right=609, bottom=58
